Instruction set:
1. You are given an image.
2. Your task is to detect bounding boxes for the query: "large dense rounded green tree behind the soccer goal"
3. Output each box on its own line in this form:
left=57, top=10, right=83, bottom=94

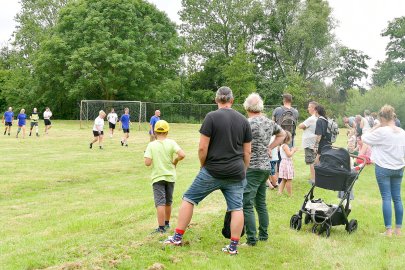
left=35, top=0, right=181, bottom=117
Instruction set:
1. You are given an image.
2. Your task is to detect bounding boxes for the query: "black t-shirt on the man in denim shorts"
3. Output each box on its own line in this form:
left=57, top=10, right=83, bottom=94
left=200, top=109, right=252, bottom=181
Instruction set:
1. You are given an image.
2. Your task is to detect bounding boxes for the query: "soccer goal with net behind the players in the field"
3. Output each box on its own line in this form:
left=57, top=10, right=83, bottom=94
left=80, top=100, right=146, bottom=130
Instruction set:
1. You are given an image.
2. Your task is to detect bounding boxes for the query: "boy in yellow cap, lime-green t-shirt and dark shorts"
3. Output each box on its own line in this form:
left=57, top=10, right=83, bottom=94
left=144, top=120, right=185, bottom=233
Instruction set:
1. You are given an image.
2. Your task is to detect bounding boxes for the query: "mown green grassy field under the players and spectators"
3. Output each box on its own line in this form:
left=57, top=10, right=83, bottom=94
left=0, top=121, right=405, bottom=269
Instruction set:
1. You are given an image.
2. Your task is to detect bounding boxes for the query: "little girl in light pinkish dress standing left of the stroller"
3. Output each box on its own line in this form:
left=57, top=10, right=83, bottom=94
left=278, top=131, right=298, bottom=196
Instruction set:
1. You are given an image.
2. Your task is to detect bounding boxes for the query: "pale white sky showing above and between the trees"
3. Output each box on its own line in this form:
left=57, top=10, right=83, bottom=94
left=0, top=0, right=405, bottom=77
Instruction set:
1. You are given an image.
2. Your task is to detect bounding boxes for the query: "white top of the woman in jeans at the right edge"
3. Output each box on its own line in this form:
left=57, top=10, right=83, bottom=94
left=361, top=126, right=405, bottom=170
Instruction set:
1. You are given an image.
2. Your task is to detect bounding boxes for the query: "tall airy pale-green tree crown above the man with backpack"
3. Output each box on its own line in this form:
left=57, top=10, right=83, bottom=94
left=256, top=0, right=334, bottom=81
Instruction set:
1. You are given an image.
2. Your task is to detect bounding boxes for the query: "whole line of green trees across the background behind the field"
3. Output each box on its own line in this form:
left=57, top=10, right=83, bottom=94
left=0, top=0, right=405, bottom=118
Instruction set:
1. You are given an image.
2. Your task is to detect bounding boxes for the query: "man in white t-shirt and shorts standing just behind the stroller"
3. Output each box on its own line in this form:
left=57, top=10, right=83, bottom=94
left=298, top=101, right=318, bottom=184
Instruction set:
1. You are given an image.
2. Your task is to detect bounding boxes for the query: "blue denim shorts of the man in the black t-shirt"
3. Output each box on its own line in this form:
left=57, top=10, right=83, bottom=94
left=183, top=168, right=246, bottom=211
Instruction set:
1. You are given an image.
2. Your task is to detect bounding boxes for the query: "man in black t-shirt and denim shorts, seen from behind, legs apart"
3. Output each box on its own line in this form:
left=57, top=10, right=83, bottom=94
left=164, top=87, right=252, bottom=254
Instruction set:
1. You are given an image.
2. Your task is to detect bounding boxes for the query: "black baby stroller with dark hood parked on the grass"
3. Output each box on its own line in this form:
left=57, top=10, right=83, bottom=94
left=290, top=146, right=364, bottom=237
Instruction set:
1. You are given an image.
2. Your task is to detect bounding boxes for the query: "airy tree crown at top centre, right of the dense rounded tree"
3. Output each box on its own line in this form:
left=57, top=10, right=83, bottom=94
left=179, top=0, right=263, bottom=58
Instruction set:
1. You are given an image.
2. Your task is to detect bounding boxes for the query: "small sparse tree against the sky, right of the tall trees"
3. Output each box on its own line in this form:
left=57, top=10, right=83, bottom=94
left=333, top=46, right=370, bottom=100
